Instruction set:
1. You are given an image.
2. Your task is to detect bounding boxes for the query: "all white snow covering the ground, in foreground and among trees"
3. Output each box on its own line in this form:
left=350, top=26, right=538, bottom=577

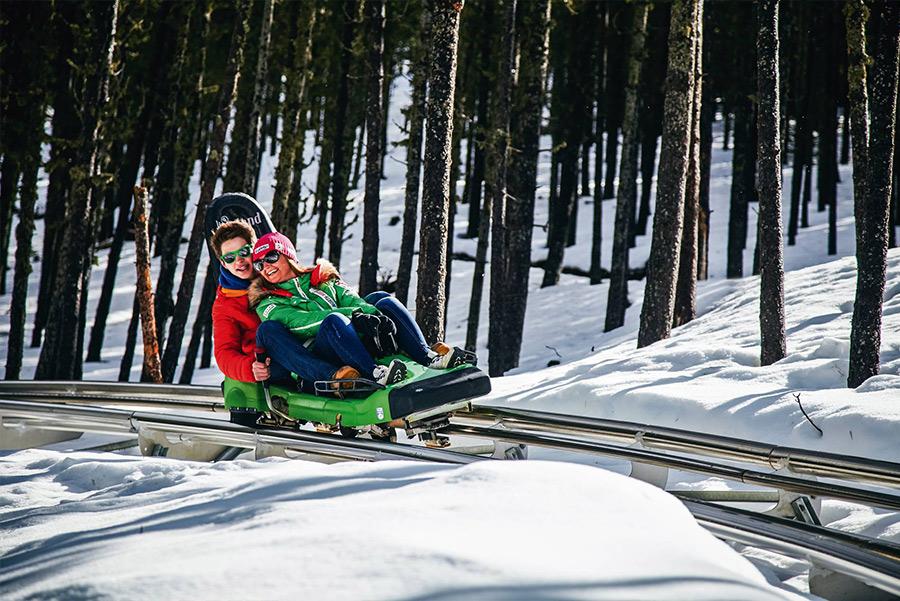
left=0, top=69, right=900, bottom=599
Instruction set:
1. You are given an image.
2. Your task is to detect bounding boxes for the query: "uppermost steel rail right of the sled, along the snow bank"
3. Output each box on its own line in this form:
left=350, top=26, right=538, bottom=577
left=460, top=405, right=900, bottom=488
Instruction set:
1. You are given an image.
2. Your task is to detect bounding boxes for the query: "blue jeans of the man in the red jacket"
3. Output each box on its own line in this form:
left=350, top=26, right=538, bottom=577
left=256, top=321, right=341, bottom=384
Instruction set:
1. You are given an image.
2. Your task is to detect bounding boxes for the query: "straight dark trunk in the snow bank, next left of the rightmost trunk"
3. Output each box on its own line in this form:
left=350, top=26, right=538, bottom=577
left=756, top=0, right=787, bottom=365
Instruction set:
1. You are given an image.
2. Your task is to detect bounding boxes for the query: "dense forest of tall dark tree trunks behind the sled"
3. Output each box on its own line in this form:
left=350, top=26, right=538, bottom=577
left=0, top=0, right=900, bottom=387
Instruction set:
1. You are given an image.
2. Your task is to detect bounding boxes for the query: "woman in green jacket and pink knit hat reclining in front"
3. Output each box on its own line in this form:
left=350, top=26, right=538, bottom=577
left=250, top=232, right=466, bottom=385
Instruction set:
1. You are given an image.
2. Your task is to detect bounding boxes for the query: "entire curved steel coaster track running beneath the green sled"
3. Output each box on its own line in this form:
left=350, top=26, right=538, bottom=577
left=0, top=382, right=900, bottom=595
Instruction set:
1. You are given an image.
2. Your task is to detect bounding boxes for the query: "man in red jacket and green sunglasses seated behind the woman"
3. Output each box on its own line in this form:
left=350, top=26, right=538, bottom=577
left=210, top=221, right=353, bottom=398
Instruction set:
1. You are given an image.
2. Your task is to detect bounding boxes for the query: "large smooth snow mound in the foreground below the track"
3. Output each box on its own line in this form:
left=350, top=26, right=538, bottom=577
left=0, top=450, right=799, bottom=600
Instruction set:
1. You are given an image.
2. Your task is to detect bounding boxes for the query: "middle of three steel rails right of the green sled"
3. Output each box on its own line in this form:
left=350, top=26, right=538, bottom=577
left=448, top=423, right=900, bottom=511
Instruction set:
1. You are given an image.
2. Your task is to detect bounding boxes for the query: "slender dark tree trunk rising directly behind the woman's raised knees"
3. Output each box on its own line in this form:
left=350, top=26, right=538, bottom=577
left=359, top=0, right=385, bottom=296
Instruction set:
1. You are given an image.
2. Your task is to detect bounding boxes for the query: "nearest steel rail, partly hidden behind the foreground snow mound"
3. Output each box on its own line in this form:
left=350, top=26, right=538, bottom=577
left=0, top=400, right=900, bottom=594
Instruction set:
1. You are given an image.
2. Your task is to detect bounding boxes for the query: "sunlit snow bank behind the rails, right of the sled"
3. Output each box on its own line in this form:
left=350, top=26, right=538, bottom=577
left=489, top=249, right=900, bottom=462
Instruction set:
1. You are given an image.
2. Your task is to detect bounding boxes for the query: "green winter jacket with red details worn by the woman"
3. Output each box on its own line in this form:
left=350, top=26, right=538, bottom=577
left=249, top=271, right=379, bottom=340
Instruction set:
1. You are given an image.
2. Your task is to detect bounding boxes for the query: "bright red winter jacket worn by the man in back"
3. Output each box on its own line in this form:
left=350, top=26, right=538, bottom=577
left=213, top=286, right=259, bottom=382
